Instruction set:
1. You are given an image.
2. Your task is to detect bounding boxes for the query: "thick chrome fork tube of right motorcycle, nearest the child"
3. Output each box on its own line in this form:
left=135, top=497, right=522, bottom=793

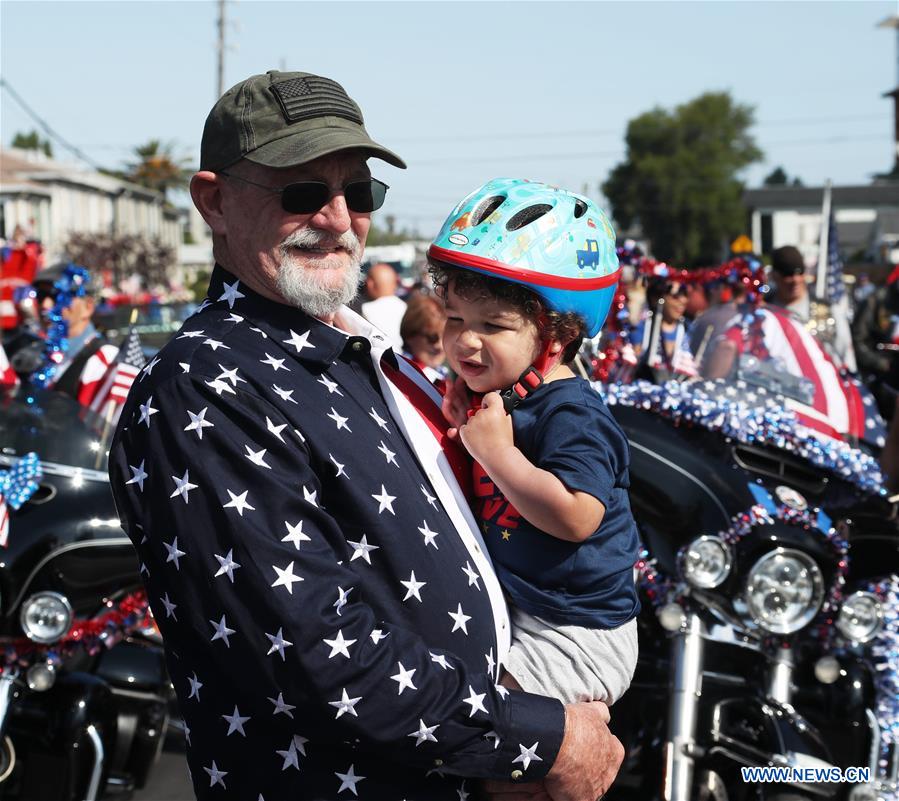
left=662, top=614, right=706, bottom=801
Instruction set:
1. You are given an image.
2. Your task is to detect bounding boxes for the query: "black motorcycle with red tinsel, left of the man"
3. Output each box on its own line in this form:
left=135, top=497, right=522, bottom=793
left=0, top=384, right=173, bottom=801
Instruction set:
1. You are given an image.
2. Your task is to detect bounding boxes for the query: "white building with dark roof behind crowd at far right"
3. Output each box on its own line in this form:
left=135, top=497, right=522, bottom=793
left=743, top=181, right=899, bottom=266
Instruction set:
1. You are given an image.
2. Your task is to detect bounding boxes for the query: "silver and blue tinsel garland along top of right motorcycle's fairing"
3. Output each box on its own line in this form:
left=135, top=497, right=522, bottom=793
left=594, top=380, right=886, bottom=495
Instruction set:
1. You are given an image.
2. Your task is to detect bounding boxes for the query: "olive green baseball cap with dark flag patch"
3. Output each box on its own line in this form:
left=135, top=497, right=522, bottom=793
left=200, top=70, right=406, bottom=172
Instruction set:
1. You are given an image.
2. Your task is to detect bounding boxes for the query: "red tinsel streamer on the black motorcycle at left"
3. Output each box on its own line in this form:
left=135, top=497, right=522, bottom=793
left=3, top=590, right=153, bottom=668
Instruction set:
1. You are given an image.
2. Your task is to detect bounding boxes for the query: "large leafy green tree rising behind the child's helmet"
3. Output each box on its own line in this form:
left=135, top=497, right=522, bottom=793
left=602, top=92, right=762, bottom=265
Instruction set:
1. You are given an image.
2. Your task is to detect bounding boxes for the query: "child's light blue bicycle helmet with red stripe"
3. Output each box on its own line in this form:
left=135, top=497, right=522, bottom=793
left=428, top=178, right=621, bottom=337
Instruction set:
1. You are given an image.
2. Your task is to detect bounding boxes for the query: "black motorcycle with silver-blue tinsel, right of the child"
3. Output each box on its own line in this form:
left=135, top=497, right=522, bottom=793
left=597, top=362, right=899, bottom=801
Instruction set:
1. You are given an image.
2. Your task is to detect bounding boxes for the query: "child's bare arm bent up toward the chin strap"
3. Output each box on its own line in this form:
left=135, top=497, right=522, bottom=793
left=459, top=392, right=606, bottom=542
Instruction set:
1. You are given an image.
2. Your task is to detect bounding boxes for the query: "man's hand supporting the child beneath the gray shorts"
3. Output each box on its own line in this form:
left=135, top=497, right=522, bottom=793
left=545, top=701, right=624, bottom=801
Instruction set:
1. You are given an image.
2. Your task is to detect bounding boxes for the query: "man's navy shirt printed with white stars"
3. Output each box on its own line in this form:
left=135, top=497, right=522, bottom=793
left=110, top=267, right=564, bottom=801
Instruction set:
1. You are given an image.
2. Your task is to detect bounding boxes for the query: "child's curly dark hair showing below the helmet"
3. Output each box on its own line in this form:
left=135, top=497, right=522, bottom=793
left=428, top=259, right=587, bottom=364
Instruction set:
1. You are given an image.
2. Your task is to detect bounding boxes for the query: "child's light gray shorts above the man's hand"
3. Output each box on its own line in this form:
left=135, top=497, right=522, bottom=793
left=505, top=607, right=637, bottom=705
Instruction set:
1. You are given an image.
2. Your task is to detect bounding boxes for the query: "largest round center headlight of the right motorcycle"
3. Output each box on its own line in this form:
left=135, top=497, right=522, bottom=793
left=746, top=548, right=824, bottom=634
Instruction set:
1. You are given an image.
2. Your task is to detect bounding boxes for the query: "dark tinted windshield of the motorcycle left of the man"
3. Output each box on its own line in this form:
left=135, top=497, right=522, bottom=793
left=0, top=390, right=114, bottom=472
